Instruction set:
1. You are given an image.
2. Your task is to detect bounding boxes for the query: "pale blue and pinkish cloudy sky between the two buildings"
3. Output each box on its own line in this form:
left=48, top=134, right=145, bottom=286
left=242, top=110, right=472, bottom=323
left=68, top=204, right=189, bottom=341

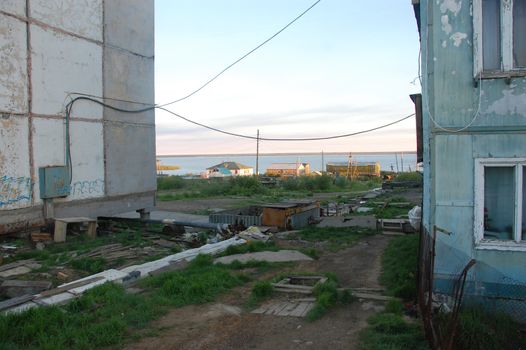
left=155, top=0, right=420, bottom=155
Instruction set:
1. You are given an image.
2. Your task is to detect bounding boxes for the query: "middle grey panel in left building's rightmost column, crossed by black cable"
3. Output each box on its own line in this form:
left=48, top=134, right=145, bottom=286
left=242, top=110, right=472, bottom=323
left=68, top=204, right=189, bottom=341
left=104, top=48, right=155, bottom=125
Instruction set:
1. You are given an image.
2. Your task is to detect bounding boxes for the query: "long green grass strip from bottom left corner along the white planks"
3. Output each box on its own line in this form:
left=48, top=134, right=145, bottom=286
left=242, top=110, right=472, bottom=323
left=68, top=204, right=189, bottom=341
left=0, top=255, right=256, bottom=349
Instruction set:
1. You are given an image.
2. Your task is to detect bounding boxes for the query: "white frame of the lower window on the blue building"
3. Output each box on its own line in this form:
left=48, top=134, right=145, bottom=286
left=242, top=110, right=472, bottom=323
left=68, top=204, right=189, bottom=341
left=473, top=158, right=526, bottom=251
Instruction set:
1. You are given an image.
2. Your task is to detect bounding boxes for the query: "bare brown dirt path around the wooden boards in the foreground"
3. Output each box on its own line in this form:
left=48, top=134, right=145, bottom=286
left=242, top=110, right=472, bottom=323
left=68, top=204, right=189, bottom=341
left=125, top=235, right=390, bottom=350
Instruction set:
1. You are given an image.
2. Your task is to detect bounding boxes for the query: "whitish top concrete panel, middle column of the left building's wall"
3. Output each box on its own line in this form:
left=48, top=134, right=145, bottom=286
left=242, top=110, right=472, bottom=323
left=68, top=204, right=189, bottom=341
left=29, top=0, right=102, bottom=41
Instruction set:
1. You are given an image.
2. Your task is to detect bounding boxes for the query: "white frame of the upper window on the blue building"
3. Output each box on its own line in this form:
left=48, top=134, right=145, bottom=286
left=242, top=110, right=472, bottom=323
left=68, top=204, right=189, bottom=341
left=472, top=0, right=526, bottom=79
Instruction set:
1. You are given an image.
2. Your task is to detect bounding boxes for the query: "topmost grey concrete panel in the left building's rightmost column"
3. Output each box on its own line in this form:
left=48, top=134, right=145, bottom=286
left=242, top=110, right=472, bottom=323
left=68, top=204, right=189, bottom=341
left=104, top=0, right=154, bottom=56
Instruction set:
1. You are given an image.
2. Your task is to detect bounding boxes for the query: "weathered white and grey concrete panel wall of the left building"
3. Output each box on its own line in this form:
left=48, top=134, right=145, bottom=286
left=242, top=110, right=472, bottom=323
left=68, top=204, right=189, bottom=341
left=0, top=0, right=156, bottom=233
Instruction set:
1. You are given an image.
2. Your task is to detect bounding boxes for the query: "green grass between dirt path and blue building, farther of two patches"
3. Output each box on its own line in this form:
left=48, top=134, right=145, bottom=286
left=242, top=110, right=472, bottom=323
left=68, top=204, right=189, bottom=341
left=380, top=234, right=418, bottom=300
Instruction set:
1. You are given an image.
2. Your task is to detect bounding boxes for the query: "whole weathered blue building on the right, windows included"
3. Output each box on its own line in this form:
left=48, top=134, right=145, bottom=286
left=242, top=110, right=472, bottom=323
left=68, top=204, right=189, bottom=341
left=412, top=0, right=526, bottom=320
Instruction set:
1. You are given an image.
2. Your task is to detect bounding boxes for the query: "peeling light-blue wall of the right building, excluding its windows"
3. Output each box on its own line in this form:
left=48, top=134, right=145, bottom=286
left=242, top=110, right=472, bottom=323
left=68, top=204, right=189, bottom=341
left=420, top=0, right=526, bottom=318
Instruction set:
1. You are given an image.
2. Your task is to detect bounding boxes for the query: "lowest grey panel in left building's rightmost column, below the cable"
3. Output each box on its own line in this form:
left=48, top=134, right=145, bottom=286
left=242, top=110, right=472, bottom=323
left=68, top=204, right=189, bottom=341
left=104, top=124, right=157, bottom=195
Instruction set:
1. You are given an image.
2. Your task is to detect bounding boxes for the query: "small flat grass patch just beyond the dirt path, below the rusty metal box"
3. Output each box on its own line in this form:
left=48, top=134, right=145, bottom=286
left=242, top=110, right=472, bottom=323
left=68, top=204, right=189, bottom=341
left=297, top=226, right=376, bottom=251
